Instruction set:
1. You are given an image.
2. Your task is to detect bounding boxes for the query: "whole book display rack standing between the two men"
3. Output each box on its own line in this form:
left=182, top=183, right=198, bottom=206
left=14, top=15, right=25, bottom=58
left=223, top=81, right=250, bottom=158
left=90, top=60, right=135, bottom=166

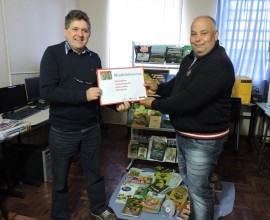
left=127, top=42, right=183, bottom=170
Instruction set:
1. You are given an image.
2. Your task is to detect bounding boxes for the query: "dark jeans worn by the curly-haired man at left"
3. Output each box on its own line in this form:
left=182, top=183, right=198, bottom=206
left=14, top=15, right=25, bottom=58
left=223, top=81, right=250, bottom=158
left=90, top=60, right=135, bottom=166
left=49, top=124, right=106, bottom=220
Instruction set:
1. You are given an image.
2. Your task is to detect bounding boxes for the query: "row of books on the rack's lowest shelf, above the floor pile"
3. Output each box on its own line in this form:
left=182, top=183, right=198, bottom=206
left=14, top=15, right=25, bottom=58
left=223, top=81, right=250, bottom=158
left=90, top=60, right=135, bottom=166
left=128, top=136, right=178, bottom=163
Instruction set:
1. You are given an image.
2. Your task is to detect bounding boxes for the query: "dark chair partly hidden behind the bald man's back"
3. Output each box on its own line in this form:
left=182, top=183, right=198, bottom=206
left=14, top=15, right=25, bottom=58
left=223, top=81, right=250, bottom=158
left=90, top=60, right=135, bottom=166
left=231, top=97, right=242, bottom=150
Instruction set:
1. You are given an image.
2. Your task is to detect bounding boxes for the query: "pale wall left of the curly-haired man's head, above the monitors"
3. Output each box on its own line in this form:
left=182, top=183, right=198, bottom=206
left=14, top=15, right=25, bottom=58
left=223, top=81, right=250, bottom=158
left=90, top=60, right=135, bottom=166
left=0, top=0, right=78, bottom=86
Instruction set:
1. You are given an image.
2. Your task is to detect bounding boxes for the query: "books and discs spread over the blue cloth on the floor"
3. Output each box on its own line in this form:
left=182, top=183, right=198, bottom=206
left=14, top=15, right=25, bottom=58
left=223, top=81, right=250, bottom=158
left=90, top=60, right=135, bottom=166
left=115, top=166, right=221, bottom=220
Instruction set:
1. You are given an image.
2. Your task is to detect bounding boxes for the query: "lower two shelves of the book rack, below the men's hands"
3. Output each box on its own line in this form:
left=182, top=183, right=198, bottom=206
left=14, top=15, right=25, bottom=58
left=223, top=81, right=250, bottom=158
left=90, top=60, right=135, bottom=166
left=127, top=103, right=177, bottom=170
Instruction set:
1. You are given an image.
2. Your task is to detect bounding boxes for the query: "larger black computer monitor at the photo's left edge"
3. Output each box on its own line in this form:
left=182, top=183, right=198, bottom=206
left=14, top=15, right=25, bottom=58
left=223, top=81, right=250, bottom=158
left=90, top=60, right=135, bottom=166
left=0, top=84, right=27, bottom=113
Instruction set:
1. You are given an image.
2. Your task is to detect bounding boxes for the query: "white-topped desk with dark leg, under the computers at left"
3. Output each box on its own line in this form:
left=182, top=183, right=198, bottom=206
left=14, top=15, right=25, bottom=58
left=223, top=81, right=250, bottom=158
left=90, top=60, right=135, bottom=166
left=0, top=108, right=49, bottom=198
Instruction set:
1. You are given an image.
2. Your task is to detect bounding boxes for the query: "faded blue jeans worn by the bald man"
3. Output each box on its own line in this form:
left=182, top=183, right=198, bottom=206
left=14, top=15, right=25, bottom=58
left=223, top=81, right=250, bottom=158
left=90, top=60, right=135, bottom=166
left=176, top=134, right=227, bottom=220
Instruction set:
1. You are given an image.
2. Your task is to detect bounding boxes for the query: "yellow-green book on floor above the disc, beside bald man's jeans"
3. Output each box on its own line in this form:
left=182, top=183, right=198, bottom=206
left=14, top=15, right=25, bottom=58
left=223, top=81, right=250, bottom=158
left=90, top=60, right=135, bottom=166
left=166, top=186, right=188, bottom=211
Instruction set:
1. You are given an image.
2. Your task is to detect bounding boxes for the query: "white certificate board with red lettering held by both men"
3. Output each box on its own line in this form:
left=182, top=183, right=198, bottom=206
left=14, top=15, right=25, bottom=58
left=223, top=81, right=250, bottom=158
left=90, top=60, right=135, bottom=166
left=97, top=67, right=147, bottom=105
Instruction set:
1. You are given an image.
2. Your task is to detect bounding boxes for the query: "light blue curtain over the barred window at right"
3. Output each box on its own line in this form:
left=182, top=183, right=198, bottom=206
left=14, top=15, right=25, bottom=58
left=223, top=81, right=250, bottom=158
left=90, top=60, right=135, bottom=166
left=216, top=0, right=270, bottom=85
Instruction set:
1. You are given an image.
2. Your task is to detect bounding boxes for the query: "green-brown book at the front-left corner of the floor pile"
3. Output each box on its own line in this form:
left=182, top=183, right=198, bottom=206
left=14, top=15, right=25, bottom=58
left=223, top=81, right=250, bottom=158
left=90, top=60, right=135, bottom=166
left=122, top=198, right=143, bottom=217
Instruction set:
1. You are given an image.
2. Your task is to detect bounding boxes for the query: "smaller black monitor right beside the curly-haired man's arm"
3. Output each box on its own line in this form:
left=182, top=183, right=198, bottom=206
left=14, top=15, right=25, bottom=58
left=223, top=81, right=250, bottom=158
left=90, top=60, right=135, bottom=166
left=24, top=76, right=40, bottom=103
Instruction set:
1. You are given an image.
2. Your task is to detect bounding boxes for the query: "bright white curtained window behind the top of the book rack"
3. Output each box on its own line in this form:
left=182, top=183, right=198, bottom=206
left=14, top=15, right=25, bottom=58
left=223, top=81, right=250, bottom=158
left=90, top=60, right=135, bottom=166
left=109, top=0, right=183, bottom=68
